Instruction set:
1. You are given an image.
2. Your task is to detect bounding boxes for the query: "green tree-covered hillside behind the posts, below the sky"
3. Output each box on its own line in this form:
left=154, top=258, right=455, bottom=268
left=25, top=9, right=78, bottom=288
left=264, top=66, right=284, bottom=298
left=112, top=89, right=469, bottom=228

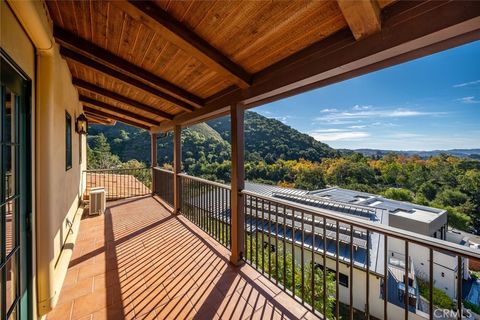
left=89, top=111, right=338, bottom=166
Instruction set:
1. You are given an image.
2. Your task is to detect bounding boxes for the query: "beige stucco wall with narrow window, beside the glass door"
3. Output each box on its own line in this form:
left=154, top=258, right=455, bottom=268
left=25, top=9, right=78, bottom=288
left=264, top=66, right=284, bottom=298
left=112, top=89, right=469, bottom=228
left=0, top=0, right=86, bottom=316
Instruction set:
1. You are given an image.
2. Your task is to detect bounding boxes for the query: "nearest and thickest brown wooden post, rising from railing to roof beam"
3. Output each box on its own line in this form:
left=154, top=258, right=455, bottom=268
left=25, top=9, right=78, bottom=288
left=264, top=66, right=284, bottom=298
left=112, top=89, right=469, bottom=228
left=230, top=103, right=245, bottom=265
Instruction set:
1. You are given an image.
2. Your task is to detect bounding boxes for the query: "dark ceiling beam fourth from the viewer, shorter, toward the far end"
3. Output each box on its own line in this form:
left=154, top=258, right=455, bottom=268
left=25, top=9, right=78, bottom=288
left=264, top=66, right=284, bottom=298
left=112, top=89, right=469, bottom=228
left=72, top=78, right=173, bottom=120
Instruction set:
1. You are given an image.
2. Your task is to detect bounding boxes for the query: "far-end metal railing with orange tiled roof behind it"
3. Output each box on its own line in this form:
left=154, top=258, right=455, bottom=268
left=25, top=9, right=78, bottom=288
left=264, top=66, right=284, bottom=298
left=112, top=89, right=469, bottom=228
left=82, top=168, right=152, bottom=201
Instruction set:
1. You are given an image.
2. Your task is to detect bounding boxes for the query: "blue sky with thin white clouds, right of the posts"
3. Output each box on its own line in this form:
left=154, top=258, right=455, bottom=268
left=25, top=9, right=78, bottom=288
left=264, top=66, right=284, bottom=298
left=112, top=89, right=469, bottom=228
left=253, top=41, right=480, bottom=150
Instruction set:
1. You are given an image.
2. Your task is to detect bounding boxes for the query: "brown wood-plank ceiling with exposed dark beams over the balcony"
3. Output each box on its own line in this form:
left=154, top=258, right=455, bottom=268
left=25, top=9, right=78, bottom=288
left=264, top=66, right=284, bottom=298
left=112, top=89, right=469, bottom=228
left=47, top=0, right=480, bottom=130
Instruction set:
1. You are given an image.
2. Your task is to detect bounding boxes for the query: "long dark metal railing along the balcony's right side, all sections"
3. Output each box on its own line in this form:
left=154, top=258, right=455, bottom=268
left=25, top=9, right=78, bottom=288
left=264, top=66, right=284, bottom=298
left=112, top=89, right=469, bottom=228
left=155, top=171, right=480, bottom=319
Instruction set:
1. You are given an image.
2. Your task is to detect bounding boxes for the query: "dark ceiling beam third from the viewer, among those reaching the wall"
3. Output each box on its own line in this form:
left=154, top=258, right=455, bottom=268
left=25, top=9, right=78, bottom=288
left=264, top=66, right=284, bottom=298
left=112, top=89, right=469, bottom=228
left=60, top=46, right=196, bottom=112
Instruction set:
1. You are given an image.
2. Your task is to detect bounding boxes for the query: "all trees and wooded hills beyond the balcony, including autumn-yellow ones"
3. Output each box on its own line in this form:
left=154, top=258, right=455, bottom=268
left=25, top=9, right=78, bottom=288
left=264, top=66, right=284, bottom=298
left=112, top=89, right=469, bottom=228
left=88, top=112, right=480, bottom=233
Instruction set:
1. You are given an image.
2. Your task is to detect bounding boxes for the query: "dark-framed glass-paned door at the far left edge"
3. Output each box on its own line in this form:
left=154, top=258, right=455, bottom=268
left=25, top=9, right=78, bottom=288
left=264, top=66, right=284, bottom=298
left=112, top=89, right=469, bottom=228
left=0, top=51, right=31, bottom=320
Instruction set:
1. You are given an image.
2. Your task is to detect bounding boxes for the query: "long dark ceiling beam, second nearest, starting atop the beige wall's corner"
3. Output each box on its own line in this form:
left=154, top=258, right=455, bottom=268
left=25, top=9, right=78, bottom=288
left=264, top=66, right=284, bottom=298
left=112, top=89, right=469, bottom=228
left=53, top=26, right=205, bottom=107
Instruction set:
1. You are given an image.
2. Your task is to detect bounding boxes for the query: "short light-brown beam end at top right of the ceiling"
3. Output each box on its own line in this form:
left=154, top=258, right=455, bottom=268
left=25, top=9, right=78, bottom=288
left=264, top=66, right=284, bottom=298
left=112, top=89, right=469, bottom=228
left=337, top=0, right=382, bottom=40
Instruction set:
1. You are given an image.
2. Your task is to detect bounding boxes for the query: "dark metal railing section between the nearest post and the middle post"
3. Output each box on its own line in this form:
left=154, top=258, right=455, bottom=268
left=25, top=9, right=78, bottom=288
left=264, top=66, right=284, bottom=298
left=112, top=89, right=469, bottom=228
left=179, top=174, right=231, bottom=248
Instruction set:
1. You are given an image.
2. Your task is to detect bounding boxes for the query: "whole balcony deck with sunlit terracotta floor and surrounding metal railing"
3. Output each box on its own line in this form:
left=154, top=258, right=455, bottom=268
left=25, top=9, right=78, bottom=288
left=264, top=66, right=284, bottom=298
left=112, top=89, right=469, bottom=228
left=48, top=168, right=480, bottom=319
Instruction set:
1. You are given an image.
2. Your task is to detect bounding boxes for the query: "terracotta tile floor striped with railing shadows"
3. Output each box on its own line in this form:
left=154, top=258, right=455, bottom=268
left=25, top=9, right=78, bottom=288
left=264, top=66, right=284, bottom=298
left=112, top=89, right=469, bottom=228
left=48, top=197, right=314, bottom=320
